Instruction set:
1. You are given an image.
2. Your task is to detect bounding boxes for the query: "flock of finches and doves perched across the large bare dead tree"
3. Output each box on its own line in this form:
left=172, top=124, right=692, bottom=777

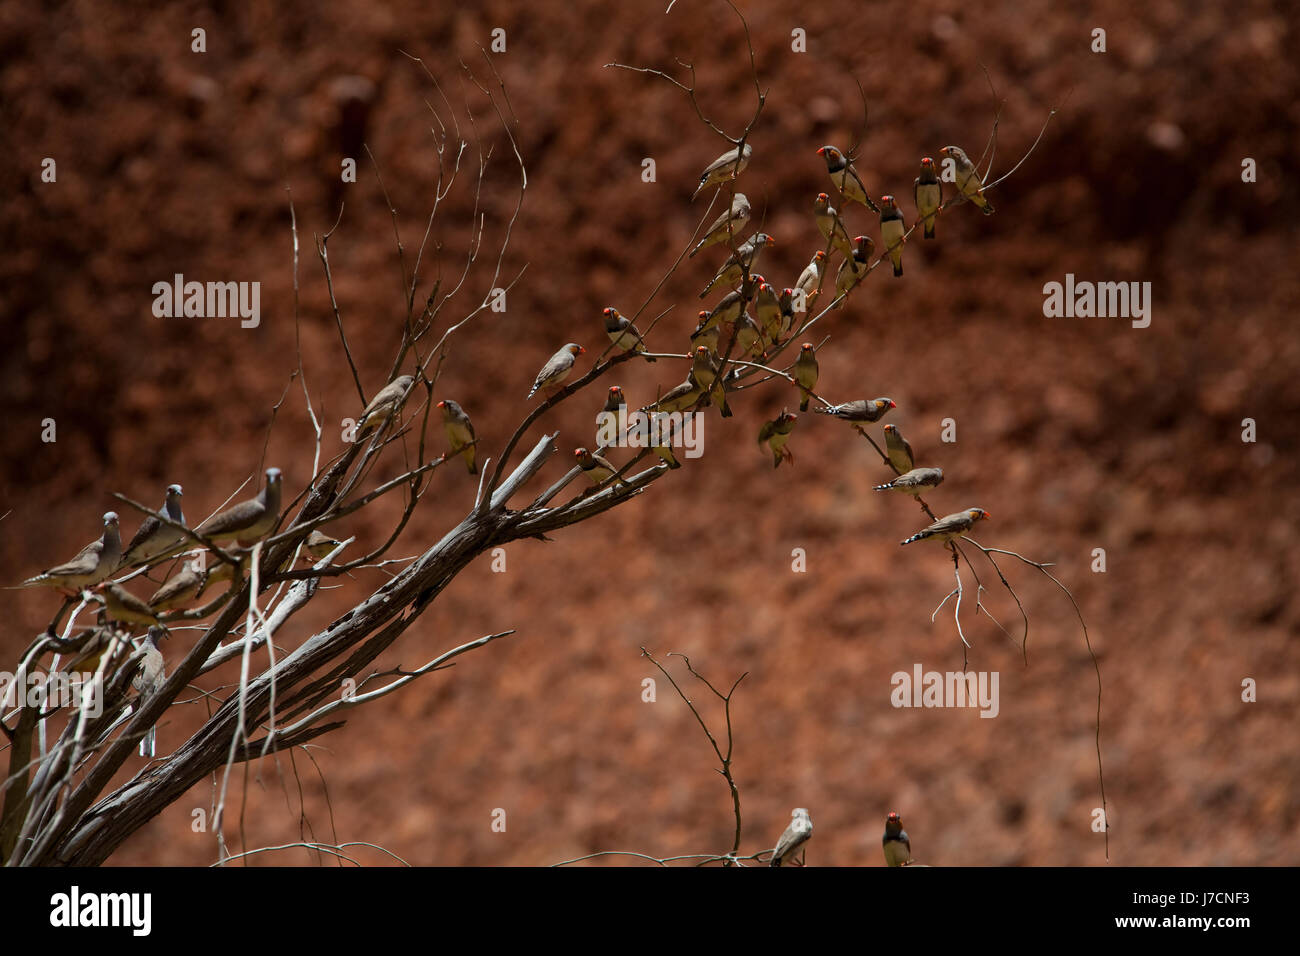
left=22, top=136, right=993, bottom=770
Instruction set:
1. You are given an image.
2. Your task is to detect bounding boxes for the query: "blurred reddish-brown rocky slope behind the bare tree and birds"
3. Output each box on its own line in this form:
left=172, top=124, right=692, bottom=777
left=0, top=3, right=1300, bottom=865
